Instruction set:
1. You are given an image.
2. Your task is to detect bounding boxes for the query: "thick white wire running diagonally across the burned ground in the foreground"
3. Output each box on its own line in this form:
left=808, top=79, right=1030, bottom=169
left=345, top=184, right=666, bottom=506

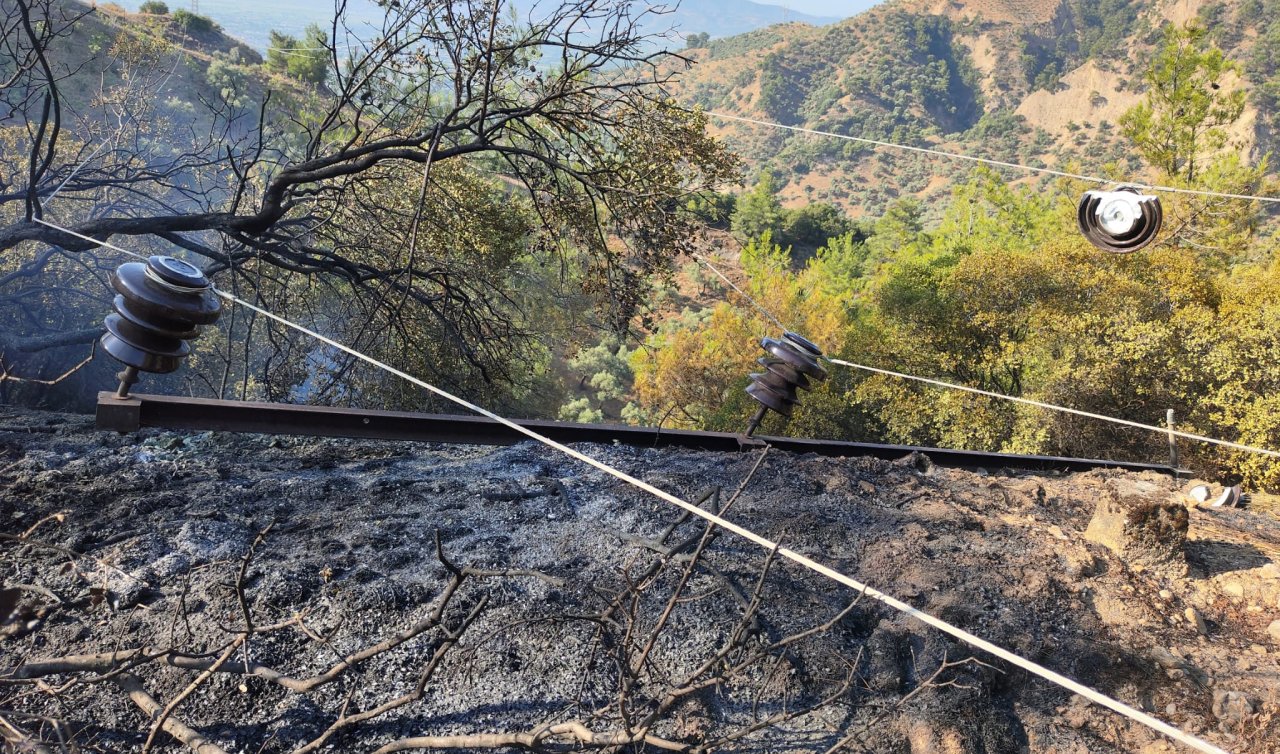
left=27, top=215, right=1228, bottom=754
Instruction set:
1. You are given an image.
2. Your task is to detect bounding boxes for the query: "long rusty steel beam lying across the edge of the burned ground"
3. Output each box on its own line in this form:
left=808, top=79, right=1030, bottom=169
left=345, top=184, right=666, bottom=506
left=97, top=392, right=1174, bottom=474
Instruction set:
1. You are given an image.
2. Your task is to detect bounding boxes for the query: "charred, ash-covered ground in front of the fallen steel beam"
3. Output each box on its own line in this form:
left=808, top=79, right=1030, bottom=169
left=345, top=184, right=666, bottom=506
left=0, top=408, right=1280, bottom=754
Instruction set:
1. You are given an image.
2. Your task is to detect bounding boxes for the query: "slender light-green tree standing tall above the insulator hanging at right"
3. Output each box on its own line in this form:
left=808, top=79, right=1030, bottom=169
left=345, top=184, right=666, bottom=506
left=1120, top=24, right=1245, bottom=182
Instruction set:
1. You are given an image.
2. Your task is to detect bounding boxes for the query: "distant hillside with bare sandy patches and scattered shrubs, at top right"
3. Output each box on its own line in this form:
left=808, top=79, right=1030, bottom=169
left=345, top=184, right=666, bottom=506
left=677, top=0, right=1280, bottom=213
